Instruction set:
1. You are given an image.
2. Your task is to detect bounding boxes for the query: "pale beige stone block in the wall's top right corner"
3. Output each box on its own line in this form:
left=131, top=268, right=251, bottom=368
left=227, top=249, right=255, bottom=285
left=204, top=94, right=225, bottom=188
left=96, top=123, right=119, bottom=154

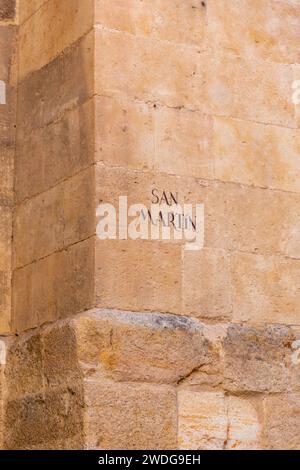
left=207, top=0, right=300, bottom=63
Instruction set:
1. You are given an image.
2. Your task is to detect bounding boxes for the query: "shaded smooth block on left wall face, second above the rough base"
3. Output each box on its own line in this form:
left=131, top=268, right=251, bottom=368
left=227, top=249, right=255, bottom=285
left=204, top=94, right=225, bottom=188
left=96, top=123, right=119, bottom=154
left=14, top=168, right=95, bottom=268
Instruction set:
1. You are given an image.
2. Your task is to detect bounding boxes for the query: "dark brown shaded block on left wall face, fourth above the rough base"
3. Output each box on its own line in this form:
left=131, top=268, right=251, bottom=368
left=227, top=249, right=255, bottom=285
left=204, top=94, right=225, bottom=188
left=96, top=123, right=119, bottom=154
left=18, top=31, right=94, bottom=133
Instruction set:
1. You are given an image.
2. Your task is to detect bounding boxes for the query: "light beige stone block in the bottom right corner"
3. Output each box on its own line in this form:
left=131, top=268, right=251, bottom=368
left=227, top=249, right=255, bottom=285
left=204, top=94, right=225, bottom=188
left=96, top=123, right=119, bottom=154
left=265, top=394, right=300, bottom=450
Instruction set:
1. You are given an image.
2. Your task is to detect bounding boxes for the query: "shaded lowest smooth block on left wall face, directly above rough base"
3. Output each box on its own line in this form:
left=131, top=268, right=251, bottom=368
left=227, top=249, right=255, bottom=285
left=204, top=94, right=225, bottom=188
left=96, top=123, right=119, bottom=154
left=13, top=238, right=94, bottom=331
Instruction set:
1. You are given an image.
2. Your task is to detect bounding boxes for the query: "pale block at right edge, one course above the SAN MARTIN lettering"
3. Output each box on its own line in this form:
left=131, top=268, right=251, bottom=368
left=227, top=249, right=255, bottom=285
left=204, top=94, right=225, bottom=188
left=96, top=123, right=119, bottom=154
left=213, top=118, right=300, bottom=192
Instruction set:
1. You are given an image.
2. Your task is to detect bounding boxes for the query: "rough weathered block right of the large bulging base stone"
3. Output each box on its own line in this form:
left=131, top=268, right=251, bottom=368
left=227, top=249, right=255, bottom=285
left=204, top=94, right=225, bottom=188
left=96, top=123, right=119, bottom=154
left=223, top=325, right=294, bottom=393
